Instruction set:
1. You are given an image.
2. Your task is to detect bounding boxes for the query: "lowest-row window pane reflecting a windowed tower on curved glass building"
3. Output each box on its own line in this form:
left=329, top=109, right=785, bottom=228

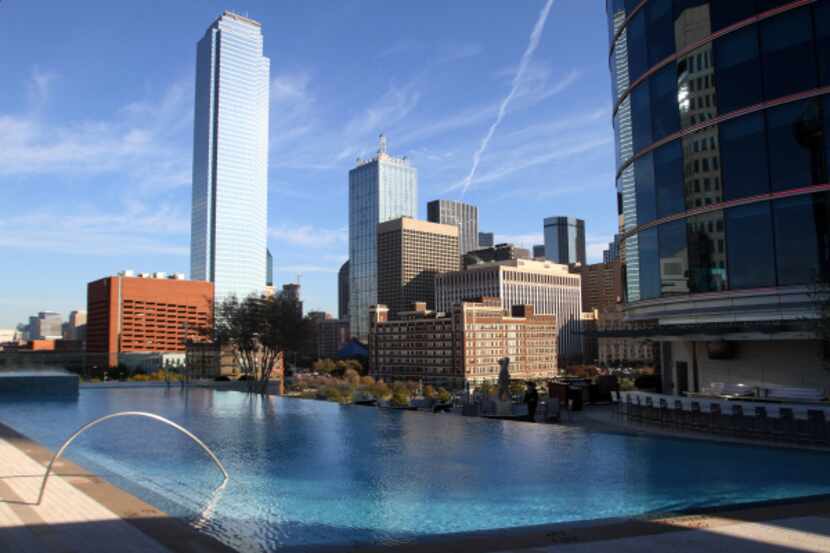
left=686, top=211, right=726, bottom=293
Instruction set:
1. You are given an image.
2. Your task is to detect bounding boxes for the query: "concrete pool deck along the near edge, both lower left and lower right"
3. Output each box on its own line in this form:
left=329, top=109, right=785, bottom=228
left=0, top=416, right=830, bottom=553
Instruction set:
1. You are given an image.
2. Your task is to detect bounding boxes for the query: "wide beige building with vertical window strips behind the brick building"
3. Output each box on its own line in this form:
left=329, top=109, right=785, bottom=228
left=435, top=259, right=582, bottom=364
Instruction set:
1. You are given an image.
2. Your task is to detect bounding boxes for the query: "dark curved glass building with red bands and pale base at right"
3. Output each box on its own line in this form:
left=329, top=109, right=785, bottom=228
left=606, top=0, right=830, bottom=392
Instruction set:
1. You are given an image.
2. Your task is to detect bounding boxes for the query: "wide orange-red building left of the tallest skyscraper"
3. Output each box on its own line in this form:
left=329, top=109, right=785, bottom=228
left=86, top=271, right=214, bottom=367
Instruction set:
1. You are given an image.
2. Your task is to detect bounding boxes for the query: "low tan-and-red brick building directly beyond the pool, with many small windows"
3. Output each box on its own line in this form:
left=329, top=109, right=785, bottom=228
left=369, top=298, right=557, bottom=390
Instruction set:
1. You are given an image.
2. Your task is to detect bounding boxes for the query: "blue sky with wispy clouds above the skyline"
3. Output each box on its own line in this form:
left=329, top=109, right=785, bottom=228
left=0, top=0, right=616, bottom=327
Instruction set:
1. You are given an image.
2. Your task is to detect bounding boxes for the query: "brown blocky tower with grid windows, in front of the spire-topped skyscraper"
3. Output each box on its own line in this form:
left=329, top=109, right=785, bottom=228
left=377, top=217, right=461, bottom=318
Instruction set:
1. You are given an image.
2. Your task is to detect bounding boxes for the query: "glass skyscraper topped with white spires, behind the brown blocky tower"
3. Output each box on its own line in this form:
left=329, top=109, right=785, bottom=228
left=349, top=135, right=418, bottom=340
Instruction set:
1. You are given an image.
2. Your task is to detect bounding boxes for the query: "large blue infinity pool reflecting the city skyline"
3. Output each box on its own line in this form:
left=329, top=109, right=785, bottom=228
left=0, top=388, right=830, bottom=552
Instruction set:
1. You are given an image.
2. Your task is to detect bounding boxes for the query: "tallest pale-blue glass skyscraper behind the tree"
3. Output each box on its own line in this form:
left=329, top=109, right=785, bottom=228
left=190, top=11, right=270, bottom=302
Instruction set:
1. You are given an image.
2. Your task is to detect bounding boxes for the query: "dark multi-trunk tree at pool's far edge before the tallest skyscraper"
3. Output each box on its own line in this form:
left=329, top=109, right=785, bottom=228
left=216, top=295, right=314, bottom=393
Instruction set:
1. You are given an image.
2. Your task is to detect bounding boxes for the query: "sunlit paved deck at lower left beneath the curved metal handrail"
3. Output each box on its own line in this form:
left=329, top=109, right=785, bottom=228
left=0, top=425, right=232, bottom=553
